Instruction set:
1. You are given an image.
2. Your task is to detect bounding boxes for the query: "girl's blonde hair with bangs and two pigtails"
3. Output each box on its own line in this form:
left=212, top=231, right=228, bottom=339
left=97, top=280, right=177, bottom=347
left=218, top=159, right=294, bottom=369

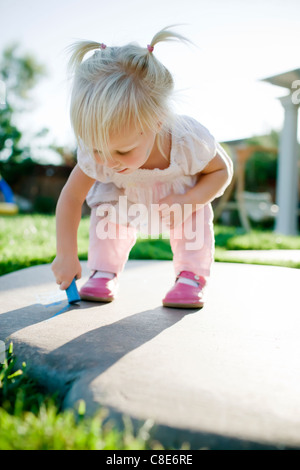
left=69, top=26, right=190, bottom=162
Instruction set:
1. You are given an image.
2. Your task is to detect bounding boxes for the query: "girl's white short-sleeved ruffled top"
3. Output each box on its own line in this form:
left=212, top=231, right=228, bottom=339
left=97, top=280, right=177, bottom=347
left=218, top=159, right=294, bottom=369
left=77, top=116, right=232, bottom=207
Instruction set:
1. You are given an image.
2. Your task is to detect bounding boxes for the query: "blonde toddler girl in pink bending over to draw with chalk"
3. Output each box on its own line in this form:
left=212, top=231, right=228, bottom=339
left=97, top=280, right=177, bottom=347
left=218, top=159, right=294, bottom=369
left=52, top=25, right=232, bottom=308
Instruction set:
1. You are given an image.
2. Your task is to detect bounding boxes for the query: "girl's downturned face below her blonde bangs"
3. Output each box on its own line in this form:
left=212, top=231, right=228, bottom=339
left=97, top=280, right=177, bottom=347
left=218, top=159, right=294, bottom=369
left=94, top=125, right=159, bottom=175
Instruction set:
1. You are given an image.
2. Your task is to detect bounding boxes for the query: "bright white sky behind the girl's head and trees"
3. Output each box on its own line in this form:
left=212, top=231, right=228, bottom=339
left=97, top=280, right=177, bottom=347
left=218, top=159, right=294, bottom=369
left=0, top=0, right=300, bottom=162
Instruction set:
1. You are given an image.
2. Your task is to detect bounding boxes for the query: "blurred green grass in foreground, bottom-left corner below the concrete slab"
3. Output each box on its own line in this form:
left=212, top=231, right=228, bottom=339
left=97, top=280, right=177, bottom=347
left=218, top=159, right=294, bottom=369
left=0, top=343, right=163, bottom=450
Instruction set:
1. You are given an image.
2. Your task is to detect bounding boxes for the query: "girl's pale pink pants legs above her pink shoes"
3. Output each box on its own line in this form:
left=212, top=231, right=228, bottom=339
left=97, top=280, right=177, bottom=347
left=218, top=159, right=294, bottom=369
left=88, top=204, right=214, bottom=277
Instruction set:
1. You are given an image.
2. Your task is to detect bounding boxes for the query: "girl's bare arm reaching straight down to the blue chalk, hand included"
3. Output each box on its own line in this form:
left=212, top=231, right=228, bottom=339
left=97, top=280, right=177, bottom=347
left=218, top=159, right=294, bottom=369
left=52, top=165, right=95, bottom=289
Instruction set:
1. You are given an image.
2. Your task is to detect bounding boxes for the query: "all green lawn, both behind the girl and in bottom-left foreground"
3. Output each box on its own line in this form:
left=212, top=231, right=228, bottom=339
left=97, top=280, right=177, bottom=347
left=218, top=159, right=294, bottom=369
left=0, top=214, right=300, bottom=450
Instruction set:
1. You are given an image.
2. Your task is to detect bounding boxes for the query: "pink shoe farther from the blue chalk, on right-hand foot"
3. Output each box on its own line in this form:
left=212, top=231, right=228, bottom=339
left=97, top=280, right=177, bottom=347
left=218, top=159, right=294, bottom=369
left=162, top=271, right=206, bottom=308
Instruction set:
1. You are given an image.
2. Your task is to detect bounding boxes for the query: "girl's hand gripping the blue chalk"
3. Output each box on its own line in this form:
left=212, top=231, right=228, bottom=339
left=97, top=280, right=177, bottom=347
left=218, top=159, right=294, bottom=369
left=51, top=256, right=81, bottom=290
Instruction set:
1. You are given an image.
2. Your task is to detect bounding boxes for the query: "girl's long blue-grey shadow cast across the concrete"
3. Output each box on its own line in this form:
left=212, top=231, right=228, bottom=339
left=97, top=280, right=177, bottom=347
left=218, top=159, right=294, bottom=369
left=0, top=302, right=199, bottom=418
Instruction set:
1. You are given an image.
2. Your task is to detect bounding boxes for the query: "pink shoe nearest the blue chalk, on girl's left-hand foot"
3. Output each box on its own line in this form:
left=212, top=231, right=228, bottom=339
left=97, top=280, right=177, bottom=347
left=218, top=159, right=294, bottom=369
left=79, top=271, right=118, bottom=302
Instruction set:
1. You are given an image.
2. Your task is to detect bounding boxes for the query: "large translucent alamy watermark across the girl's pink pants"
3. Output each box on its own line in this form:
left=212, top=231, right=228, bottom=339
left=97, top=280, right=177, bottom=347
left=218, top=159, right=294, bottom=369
left=96, top=196, right=204, bottom=250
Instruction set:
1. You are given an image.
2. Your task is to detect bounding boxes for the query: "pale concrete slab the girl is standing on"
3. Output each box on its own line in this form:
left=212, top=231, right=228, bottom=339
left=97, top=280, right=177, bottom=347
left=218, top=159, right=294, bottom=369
left=0, top=261, right=300, bottom=449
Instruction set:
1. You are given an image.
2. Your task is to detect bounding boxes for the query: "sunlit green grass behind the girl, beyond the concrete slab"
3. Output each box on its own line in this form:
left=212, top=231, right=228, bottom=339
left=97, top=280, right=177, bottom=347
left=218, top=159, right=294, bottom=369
left=0, top=214, right=300, bottom=275
